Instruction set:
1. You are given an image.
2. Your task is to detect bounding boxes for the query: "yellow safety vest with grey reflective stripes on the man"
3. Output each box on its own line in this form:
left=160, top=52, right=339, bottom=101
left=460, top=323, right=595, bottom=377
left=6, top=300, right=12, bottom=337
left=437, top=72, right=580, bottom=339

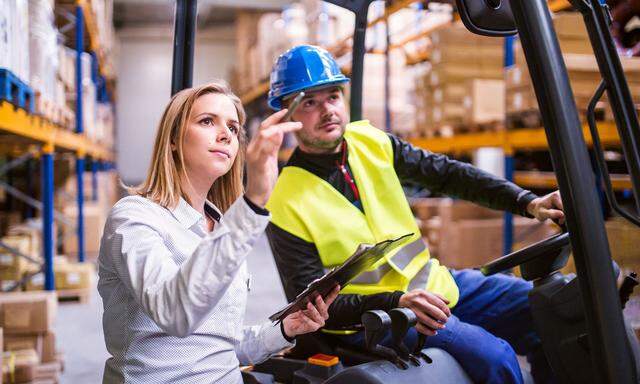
left=267, top=120, right=459, bottom=332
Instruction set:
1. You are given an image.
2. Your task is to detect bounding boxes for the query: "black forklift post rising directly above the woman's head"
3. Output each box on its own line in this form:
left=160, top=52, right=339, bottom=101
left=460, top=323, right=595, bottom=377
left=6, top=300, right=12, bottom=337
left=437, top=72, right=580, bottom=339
left=171, top=0, right=198, bottom=95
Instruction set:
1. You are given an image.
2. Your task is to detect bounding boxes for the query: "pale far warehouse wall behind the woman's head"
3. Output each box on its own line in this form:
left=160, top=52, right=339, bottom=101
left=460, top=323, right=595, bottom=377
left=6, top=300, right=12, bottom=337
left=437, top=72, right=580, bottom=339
left=116, top=27, right=235, bottom=185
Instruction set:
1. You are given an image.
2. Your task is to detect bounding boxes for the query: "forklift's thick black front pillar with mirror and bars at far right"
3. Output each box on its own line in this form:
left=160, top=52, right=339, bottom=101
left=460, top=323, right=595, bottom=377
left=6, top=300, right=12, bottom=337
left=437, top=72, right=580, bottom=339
left=456, top=0, right=640, bottom=383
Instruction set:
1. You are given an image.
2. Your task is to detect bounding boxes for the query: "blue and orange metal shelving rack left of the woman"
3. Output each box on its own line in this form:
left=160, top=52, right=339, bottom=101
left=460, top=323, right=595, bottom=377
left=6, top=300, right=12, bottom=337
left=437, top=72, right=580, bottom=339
left=0, top=0, right=115, bottom=290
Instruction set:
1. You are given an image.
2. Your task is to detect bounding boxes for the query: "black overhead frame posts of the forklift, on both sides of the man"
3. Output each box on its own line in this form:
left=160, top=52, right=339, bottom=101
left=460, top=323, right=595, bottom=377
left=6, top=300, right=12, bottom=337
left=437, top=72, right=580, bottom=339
left=171, top=0, right=640, bottom=383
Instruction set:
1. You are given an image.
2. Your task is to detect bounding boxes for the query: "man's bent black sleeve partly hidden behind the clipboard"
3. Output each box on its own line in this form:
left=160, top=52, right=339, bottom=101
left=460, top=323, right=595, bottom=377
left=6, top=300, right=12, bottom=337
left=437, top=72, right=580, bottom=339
left=267, top=223, right=402, bottom=329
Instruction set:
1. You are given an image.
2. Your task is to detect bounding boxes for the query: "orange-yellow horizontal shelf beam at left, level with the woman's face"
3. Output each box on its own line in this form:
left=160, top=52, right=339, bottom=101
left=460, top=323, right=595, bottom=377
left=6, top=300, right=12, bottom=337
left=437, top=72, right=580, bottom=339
left=0, top=101, right=114, bottom=161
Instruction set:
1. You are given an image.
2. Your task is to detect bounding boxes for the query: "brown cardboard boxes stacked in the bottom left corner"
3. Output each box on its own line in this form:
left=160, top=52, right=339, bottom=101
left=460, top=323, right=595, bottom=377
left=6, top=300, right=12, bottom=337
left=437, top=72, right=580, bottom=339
left=0, top=292, right=61, bottom=383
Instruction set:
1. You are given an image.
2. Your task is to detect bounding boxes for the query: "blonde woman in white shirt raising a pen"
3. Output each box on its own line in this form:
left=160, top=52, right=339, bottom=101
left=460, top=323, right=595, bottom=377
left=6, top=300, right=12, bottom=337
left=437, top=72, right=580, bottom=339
left=98, top=83, right=337, bottom=384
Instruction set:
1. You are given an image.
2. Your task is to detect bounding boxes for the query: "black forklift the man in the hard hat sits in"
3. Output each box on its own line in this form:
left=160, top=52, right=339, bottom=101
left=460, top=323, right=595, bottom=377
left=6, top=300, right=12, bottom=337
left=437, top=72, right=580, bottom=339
left=171, top=0, right=640, bottom=384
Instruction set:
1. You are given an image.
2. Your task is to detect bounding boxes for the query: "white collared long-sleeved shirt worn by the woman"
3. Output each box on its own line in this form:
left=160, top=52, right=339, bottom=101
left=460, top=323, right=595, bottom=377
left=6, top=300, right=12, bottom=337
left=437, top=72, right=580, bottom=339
left=98, top=196, right=292, bottom=384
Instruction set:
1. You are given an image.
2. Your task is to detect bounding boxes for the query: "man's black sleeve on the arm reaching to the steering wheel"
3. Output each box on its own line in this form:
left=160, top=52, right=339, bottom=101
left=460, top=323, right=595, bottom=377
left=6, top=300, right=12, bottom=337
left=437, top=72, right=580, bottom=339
left=389, top=135, right=537, bottom=217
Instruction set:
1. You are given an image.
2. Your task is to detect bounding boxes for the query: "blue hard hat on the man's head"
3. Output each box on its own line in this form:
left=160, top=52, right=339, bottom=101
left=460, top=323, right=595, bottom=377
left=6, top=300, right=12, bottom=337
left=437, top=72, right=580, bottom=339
left=268, top=45, right=349, bottom=111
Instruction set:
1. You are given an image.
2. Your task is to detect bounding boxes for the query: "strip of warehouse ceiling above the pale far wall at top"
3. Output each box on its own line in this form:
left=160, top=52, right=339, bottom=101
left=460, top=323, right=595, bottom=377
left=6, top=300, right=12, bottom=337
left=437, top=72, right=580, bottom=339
left=113, top=0, right=292, bottom=28
